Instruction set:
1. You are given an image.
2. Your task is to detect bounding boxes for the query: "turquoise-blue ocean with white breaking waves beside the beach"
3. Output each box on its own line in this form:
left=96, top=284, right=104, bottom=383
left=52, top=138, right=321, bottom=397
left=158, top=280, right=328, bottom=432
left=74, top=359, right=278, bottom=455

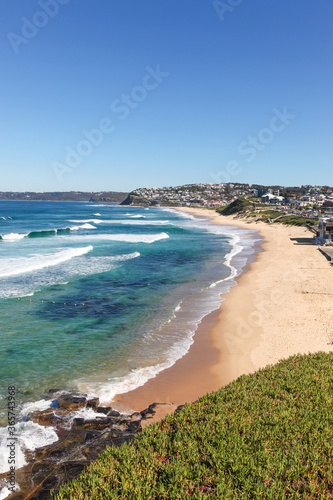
left=0, top=201, right=260, bottom=480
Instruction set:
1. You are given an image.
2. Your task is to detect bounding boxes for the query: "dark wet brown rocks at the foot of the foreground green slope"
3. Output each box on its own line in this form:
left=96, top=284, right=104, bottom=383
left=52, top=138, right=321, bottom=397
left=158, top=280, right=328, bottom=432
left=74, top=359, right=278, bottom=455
left=3, top=392, right=174, bottom=500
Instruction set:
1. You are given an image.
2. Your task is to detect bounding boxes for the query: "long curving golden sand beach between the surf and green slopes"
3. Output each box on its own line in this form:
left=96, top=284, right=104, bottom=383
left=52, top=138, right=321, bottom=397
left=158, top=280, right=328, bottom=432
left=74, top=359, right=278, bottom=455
left=116, top=208, right=333, bottom=419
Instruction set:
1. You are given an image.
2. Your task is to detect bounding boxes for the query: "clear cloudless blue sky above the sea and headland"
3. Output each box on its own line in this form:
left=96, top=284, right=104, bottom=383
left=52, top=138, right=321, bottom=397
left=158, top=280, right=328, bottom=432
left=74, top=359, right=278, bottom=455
left=0, top=0, right=333, bottom=191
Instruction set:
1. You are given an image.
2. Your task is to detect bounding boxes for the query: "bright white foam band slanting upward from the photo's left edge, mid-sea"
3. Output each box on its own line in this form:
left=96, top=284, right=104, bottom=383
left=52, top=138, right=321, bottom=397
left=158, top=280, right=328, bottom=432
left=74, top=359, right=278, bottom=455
left=0, top=245, right=93, bottom=278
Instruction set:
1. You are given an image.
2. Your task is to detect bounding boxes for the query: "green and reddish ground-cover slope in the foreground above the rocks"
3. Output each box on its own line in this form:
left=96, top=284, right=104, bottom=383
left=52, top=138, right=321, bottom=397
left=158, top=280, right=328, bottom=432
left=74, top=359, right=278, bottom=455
left=55, top=353, right=333, bottom=500
